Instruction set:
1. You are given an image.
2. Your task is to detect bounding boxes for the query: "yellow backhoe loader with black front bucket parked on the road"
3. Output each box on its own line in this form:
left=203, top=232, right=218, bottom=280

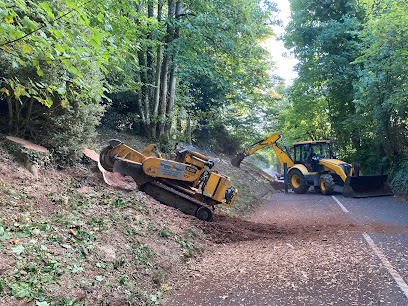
left=231, top=133, right=392, bottom=197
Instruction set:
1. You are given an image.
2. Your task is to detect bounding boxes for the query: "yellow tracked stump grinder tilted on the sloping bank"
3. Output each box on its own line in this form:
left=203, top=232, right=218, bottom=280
left=99, top=139, right=238, bottom=221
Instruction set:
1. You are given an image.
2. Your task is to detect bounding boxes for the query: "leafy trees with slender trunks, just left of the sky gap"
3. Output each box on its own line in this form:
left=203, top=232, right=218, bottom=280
left=99, top=0, right=276, bottom=141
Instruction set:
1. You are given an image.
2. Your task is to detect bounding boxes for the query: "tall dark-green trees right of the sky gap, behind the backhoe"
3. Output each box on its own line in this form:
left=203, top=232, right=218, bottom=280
left=277, top=0, right=408, bottom=188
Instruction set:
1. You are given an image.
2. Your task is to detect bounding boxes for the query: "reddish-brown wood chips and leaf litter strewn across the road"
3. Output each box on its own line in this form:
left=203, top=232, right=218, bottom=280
left=164, top=193, right=404, bottom=305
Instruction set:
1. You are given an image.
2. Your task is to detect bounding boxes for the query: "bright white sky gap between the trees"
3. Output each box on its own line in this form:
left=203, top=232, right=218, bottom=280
left=265, top=0, right=297, bottom=85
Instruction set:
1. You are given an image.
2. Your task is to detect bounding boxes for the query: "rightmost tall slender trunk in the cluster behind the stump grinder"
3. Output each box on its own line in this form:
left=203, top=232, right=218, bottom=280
left=159, top=0, right=175, bottom=135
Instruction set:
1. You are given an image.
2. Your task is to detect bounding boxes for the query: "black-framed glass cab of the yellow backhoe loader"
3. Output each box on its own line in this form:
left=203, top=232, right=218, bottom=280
left=293, top=140, right=334, bottom=172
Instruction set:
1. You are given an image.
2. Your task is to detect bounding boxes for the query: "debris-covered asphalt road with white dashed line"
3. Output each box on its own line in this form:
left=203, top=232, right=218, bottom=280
left=165, top=192, right=408, bottom=305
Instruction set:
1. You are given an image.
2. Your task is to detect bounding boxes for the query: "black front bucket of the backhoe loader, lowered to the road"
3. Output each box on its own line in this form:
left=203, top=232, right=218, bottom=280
left=343, top=175, right=393, bottom=198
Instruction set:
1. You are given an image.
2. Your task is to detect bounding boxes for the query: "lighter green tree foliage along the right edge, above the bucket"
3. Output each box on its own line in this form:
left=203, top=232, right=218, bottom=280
left=355, top=0, right=408, bottom=163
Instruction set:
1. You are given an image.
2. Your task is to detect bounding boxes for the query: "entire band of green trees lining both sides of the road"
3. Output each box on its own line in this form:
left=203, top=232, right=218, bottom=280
left=0, top=0, right=408, bottom=192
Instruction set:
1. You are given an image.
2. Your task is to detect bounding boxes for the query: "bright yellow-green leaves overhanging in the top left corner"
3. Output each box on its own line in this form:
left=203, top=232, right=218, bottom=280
left=0, top=0, right=108, bottom=107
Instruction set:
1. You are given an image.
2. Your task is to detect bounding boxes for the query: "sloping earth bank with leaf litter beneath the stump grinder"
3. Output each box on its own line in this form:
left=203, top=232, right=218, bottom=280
left=0, top=133, right=280, bottom=305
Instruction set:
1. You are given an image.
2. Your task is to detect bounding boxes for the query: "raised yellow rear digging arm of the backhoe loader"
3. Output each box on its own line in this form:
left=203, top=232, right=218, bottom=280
left=231, top=133, right=294, bottom=168
